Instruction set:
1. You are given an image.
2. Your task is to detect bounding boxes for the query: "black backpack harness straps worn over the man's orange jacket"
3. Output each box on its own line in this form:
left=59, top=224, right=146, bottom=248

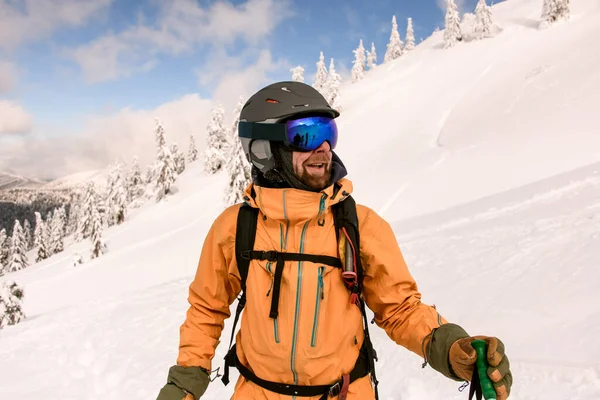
left=222, top=193, right=379, bottom=400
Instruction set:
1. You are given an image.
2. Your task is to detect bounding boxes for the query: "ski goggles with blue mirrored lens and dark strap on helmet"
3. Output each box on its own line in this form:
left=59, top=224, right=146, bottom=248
left=238, top=117, right=338, bottom=151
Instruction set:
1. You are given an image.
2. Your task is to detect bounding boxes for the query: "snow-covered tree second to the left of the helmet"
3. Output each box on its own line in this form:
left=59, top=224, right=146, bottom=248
left=204, top=104, right=229, bottom=174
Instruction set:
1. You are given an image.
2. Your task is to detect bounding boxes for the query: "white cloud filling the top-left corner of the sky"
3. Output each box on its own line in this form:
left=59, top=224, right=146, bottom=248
left=0, top=0, right=113, bottom=49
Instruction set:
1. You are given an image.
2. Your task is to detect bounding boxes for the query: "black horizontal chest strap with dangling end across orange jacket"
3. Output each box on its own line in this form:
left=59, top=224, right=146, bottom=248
left=241, top=250, right=342, bottom=319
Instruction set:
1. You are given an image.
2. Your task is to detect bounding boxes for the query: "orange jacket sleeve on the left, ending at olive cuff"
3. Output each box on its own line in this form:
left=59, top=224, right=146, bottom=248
left=177, top=206, right=241, bottom=371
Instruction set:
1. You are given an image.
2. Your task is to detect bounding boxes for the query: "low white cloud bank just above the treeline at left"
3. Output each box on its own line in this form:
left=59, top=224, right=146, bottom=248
left=0, top=94, right=213, bottom=179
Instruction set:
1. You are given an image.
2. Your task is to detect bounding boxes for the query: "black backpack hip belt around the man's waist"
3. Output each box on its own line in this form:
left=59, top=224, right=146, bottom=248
left=225, top=345, right=369, bottom=400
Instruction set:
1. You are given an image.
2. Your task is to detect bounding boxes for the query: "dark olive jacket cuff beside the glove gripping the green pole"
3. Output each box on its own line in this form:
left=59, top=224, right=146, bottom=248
left=423, top=323, right=470, bottom=381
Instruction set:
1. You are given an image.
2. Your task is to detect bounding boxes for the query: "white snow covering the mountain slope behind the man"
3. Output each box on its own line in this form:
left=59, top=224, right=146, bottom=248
left=0, top=0, right=600, bottom=400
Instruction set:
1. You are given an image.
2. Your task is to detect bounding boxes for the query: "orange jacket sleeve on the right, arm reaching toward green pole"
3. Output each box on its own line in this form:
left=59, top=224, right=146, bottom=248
left=359, top=207, right=447, bottom=358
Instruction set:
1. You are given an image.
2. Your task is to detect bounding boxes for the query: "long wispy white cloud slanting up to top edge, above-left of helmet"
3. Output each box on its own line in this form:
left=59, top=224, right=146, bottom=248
left=65, top=0, right=292, bottom=83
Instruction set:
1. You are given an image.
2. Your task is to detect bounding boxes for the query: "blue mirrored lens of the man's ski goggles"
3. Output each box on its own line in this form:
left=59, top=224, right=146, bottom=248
left=285, top=117, right=337, bottom=151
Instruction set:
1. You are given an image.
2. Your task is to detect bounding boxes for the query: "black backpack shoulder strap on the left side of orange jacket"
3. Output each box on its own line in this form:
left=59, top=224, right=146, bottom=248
left=222, top=203, right=258, bottom=385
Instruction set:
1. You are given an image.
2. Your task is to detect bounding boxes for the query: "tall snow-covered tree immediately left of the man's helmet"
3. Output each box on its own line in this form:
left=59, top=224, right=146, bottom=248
left=225, top=97, right=252, bottom=205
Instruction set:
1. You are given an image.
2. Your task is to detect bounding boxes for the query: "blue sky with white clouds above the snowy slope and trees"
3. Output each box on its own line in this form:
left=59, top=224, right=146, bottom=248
left=0, top=0, right=488, bottom=178
